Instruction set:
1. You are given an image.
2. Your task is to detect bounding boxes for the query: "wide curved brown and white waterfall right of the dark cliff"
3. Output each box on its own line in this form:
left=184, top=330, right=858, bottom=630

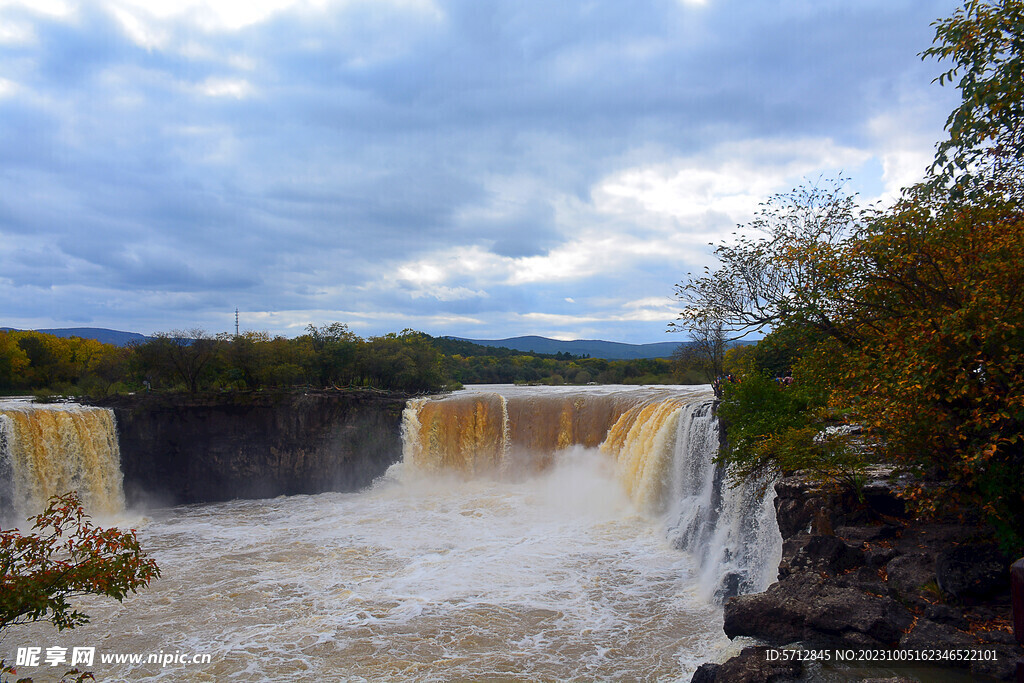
left=402, top=387, right=781, bottom=602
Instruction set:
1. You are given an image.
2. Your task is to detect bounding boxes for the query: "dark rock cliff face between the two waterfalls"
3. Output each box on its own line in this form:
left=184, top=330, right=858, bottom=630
left=94, top=391, right=408, bottom=505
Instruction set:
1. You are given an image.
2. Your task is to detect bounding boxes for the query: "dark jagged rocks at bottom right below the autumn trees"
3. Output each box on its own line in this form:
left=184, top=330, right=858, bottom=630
left=693, top=473, right=1024, bottom=682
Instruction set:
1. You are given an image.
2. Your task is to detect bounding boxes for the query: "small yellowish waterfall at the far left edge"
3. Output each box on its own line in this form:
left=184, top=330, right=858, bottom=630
left=0, top=400, right=124, bottom=523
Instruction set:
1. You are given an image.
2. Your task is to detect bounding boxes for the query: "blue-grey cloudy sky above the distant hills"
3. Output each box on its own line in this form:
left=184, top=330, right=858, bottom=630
left=0, top=0, right=959, bottom=343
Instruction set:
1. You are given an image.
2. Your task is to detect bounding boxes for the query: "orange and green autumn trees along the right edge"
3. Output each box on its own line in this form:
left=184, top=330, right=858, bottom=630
left=677, top=0, right=1024, bottom=552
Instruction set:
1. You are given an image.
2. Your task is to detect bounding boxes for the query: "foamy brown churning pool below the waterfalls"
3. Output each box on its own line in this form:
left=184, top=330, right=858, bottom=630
left=9, top=449, right=730, bottom=681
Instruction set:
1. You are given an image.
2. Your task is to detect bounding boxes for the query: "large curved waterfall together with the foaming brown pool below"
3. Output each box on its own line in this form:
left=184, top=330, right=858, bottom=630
left=0, top=387, right=778, bottom=681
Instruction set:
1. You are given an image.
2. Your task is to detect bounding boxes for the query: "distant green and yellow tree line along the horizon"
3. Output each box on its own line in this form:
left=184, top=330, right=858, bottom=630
left=0, top=323, right=706, bottom=395
